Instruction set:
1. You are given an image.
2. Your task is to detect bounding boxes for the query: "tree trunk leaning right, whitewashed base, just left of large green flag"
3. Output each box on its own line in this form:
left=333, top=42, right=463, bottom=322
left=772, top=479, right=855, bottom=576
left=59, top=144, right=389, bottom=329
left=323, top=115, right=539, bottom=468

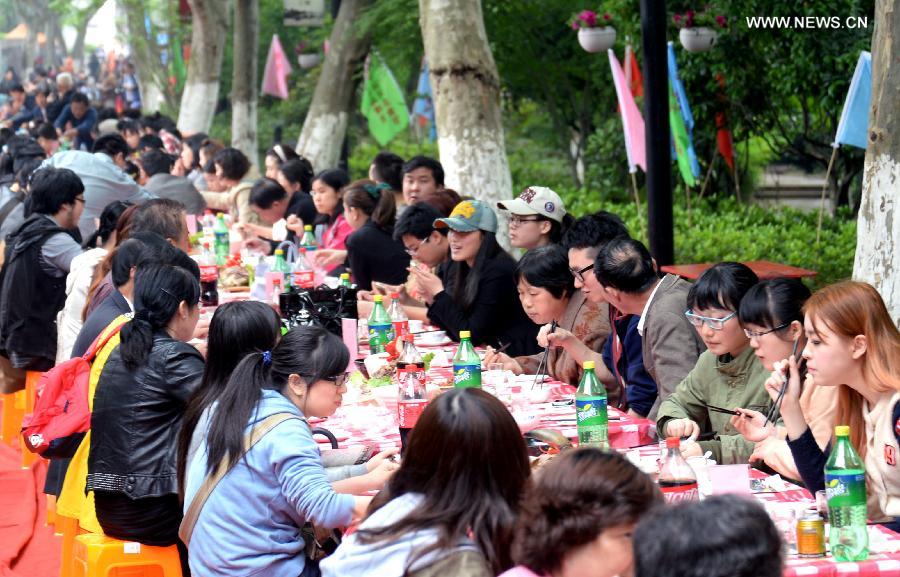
left=297, top=0, right=371, bottom=170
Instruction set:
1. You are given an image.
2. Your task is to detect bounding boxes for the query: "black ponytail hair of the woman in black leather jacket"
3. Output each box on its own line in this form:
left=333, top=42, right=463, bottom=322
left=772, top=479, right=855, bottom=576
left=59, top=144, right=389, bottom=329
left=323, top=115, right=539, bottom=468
left=119, top=264, right=200, bottom=370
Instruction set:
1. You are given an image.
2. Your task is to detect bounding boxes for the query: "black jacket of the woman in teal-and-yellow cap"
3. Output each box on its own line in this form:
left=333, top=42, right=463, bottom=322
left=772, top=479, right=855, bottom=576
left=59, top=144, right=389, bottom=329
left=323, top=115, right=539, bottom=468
left=428, top=254, right=541, bottom=357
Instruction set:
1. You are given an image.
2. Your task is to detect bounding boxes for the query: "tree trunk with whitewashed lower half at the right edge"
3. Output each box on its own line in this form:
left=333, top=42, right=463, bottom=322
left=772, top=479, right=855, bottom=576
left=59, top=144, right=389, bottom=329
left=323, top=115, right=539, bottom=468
left=853, top=0, right=900, bottom=323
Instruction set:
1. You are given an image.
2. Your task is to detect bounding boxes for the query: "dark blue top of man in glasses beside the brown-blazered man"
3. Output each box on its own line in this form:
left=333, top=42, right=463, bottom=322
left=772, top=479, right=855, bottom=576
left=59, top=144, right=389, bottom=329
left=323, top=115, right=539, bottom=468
left=602, top=315, right=657, bottom=416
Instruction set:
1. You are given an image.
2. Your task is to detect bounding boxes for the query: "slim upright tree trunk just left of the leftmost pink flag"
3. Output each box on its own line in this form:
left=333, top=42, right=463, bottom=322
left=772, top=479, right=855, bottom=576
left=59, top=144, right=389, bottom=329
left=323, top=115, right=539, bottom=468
left=231, top=0, right=259, bottom=164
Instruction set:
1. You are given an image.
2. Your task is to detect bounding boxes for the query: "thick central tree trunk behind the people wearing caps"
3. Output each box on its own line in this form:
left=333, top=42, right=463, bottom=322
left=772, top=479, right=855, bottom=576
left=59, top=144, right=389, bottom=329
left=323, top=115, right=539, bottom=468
left=419, top=0, right=512, bottom=207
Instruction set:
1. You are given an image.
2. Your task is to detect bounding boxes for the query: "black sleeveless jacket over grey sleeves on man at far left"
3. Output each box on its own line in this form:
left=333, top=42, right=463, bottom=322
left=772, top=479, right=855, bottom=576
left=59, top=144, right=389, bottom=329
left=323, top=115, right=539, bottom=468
left=0, top=214, right=74, bottom=370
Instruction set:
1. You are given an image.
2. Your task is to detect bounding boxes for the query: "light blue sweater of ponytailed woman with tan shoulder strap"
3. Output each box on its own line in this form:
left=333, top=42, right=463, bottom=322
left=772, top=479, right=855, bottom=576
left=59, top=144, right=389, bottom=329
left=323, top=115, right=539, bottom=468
left=184, top=391, right=354, bottom=577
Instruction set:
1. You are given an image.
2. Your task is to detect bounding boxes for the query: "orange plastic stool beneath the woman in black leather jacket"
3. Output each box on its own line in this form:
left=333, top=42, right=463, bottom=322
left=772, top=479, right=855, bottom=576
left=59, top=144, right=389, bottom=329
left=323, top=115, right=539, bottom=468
left=72, top=533, right=181, bottom=577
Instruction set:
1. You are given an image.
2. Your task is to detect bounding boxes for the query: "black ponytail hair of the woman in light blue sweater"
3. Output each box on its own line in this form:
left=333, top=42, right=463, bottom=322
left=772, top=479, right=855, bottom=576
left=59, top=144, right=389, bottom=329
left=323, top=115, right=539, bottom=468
left=206, top=326, right=350, bottom=473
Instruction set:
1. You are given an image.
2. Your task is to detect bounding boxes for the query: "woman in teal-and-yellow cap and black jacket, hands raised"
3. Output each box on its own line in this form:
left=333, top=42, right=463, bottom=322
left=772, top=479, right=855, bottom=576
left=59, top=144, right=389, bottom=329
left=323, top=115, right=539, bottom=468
left=409, top=200, right=540, bottom=356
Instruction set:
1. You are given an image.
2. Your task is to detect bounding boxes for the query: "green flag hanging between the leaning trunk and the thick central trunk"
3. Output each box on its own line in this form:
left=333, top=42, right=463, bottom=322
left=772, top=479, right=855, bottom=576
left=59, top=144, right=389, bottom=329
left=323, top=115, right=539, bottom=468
left=360, top=52, right=409, bottom=146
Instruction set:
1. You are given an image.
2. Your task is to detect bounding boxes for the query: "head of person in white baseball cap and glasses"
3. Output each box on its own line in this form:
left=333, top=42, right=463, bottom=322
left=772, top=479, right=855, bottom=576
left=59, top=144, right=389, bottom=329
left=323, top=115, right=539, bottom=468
left=497, top=186, right=575, bottom=250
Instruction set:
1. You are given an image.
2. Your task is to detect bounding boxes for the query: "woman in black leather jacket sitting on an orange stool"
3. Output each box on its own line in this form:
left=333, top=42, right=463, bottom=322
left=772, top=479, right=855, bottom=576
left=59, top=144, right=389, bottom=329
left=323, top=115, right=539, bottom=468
left=85, top=264, right=203, bottom=563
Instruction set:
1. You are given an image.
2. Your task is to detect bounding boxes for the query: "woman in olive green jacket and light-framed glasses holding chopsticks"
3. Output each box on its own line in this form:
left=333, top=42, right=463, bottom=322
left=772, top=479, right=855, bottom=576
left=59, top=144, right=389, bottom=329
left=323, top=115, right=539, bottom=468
left=656, top=262, right=769, bottom=464
